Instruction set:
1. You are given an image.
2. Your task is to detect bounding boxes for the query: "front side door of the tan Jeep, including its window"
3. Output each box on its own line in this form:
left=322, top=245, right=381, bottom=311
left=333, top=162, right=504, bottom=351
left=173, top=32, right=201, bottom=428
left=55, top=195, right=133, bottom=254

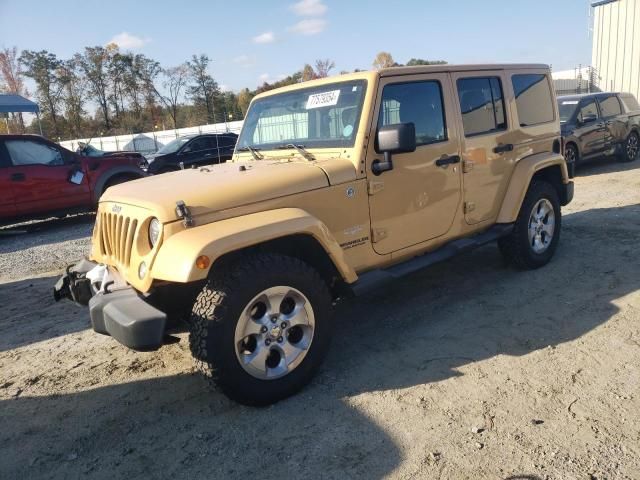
left=367, top=73, right=461, bottom=254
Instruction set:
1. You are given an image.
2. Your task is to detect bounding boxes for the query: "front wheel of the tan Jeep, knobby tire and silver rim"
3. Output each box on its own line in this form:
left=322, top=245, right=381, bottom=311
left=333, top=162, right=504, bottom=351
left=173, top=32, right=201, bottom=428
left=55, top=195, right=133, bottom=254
left=189, top=254, right=332, bottom=405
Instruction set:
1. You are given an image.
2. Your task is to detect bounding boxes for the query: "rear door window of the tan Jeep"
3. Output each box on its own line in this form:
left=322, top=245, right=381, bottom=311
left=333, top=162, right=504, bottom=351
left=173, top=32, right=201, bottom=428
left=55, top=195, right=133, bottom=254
left=457, top=77, right=507, bottom=137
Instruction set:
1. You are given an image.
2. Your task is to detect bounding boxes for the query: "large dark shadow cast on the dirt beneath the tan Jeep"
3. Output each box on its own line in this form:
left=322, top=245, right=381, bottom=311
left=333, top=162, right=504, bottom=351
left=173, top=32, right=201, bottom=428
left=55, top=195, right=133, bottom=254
left=0, top=205, right=640, bottom=478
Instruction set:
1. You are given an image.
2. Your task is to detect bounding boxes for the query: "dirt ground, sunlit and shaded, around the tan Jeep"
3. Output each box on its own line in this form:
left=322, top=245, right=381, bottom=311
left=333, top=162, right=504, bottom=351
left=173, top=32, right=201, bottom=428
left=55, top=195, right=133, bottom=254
left=0, top=161, right=640, bottom=480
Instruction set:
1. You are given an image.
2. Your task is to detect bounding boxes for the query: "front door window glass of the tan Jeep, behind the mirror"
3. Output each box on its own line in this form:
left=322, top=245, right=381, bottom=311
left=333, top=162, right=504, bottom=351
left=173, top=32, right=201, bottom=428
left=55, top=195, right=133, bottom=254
left=378, top=80, right=447, bottom=146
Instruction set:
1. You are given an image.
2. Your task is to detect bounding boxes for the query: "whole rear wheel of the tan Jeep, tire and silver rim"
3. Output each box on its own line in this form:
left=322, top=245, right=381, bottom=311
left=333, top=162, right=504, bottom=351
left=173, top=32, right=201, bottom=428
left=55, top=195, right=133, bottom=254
left=498, top=180, right=562, bottom=269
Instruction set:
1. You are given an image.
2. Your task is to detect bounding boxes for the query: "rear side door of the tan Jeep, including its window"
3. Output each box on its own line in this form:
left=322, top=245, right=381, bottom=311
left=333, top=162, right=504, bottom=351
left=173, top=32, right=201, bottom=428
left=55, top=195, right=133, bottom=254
left=452, top=71, right=515, bottom=225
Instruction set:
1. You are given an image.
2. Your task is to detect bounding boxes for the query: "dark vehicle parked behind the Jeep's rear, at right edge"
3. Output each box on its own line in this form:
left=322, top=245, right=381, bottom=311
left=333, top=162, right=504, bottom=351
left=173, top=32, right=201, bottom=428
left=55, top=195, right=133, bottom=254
left=558, top=92, right=640, bottom=168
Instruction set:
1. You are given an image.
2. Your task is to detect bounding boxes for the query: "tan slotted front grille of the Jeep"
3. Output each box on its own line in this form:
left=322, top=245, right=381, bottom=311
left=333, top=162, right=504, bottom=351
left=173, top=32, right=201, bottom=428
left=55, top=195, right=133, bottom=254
left=98, top=212, right=138, bottom=267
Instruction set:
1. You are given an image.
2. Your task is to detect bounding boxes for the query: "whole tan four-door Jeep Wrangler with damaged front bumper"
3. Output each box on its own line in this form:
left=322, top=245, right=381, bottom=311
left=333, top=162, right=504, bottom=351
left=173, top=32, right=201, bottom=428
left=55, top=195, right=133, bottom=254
left=55, top=65, right=573, bottom=405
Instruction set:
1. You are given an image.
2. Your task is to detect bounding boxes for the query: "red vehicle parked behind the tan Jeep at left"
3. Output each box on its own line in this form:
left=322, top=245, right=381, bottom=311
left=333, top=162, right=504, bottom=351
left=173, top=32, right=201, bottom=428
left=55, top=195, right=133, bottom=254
left=0, top=135, right=145, bottom=224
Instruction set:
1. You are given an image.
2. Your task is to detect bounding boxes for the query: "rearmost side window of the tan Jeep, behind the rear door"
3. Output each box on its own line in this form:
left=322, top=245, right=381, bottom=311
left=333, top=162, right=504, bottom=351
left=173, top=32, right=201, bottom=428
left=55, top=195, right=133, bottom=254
left=511, top=73, right=554, bottom=127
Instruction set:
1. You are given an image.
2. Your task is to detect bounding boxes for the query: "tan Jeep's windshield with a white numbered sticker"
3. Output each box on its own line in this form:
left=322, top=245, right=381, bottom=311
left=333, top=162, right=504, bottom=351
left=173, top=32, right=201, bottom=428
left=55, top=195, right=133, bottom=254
left=237, top=80, right=366, bottom=150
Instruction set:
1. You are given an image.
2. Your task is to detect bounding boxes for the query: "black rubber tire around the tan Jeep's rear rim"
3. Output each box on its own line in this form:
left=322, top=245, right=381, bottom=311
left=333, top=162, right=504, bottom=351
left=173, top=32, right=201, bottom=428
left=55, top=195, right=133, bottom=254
left=498, top=180, right=562, bottom=270
